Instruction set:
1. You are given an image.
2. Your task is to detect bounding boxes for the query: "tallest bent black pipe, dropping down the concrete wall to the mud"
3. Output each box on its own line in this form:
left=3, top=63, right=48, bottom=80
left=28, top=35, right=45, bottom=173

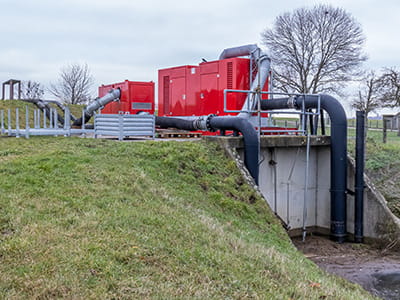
left=261, top=95, right=347, bottom=243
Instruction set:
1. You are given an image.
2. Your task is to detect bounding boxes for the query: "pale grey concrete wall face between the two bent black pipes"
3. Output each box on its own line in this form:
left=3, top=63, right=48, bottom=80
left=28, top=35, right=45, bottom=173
left=259, top=146, right=330, bottom=228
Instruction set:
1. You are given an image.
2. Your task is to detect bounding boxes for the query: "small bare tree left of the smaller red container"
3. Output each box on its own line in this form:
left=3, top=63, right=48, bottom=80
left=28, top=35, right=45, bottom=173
left=49, top=64, right=93, bottom=104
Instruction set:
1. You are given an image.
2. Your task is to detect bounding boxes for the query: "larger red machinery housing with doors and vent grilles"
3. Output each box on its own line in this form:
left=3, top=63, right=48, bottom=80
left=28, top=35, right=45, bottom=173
left=158, top=58, right=268, bottom=116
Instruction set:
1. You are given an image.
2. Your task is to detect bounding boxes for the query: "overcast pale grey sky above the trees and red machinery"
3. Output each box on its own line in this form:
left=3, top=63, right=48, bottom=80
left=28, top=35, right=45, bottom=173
left=0, top=0, right=400, bottom=106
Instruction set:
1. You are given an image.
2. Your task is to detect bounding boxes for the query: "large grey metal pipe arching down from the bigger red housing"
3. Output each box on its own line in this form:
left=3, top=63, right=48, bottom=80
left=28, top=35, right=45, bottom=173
left=219, top=44, right=271, bottom=119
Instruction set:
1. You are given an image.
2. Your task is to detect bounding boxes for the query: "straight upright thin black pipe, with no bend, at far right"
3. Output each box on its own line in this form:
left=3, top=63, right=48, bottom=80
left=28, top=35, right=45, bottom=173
left=354, top=111, right=365, bottom=243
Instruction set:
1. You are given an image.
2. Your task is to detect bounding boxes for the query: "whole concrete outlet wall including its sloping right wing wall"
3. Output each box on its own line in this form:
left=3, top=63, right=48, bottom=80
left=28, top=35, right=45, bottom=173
left=208, top=136, right=400, bottom=245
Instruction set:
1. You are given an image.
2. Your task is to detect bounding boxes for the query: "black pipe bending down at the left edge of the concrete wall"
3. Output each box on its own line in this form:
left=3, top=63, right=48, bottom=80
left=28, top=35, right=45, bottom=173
left=156, top=116, right=260, bottom=185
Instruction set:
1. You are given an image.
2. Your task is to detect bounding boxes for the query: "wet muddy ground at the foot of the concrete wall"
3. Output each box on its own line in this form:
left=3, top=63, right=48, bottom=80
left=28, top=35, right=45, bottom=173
left=292, top=236, right=400, bottom=299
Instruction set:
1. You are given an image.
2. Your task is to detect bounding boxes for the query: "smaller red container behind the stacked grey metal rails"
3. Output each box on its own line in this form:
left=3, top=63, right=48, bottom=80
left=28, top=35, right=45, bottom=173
left=99, top=80, right=155, bottom=114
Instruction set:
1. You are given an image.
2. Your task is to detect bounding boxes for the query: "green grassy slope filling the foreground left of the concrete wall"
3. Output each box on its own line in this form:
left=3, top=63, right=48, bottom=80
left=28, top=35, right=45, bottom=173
left=0, top=137, right=370, bottom=299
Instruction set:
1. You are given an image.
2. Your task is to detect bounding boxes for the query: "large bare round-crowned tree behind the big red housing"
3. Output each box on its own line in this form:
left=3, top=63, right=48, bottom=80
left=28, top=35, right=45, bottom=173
left=262, top=5, right=367, bottom=95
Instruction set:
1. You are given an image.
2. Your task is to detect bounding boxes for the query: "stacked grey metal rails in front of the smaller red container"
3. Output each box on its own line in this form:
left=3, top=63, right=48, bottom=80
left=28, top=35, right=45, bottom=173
left=94, top=114, right=155, bottom=141
